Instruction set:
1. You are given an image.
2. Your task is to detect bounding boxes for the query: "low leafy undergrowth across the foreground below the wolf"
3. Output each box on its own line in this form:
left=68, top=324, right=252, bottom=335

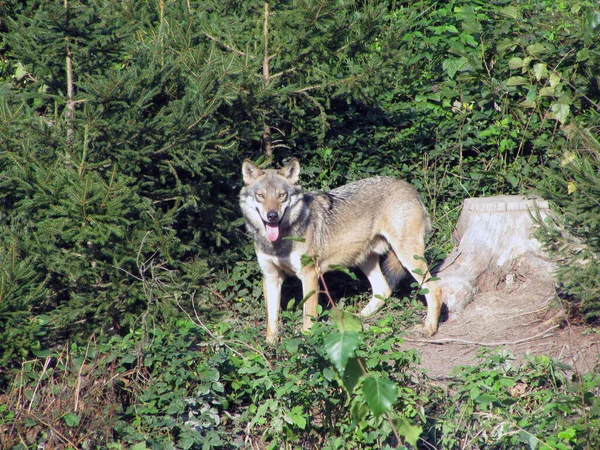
left=0, top=296, right=600, bottom=450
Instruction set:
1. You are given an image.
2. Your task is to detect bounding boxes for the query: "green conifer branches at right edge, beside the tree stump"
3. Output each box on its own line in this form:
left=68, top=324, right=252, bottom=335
left=537, top=125, right=600, bottom=321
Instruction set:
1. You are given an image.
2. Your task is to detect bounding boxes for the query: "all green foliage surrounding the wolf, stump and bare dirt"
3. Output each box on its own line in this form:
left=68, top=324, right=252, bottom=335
left=0, top=0, right=600, bottom=449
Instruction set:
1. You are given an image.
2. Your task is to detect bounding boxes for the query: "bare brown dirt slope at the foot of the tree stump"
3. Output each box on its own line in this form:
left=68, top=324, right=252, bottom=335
left=403, top=283, right=600, bottom=382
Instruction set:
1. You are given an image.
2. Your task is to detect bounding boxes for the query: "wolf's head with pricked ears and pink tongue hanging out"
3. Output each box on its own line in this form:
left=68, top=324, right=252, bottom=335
left=240, top=158, right=303, bottom=242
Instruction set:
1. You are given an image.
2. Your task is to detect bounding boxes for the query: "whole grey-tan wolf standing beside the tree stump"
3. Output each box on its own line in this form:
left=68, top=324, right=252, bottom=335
left=239, top=158, right=442, bottom=342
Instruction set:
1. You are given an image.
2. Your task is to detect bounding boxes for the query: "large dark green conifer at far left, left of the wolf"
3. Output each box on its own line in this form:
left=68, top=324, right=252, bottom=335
left=0, top=1, right=233, bottom=358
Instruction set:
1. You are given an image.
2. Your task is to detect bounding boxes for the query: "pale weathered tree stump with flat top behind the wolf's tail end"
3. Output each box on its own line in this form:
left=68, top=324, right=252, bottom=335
left=435, top=195, right=554, bottom=317
